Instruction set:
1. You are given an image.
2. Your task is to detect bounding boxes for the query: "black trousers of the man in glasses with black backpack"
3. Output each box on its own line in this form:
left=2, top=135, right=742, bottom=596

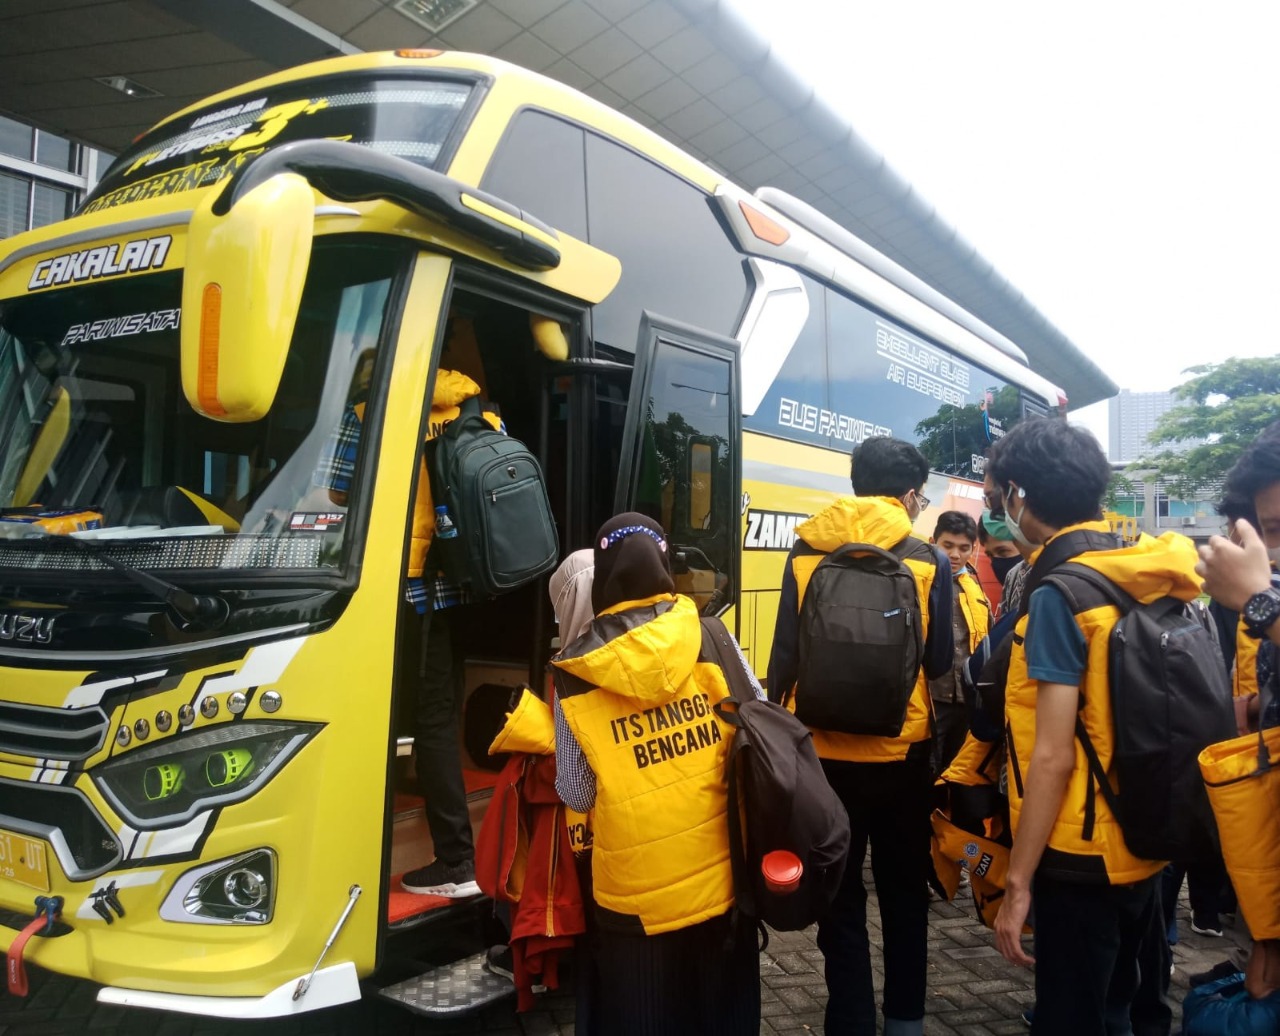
left=818, top=741, right=933, bottom=1036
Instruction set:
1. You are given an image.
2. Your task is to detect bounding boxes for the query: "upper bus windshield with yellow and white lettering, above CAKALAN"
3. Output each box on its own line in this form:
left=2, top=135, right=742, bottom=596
left=81, top=76, right=474, bottom=213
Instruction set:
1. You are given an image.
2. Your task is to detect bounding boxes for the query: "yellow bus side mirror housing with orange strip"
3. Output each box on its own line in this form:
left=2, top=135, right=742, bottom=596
left=182, top=173, right=315, bottom=423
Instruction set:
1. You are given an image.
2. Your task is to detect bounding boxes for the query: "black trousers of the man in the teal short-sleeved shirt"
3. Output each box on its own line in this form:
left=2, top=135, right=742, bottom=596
left=1032, top=875, right=1167, bottom=1036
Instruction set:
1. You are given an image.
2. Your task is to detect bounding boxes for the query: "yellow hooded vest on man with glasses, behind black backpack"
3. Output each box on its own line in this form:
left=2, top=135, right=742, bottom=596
left=771, top=497, right=937, bottom=762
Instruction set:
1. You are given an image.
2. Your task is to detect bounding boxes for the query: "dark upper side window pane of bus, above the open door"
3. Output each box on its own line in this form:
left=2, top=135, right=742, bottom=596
left=586, top=133, right=748, bottom=352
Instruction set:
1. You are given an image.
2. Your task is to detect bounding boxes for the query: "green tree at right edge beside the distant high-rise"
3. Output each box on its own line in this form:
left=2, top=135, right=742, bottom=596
left=1130, top=356, right=1280, bottom=499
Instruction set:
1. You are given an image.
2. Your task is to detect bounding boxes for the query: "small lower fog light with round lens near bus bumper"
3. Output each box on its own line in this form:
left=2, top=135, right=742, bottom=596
left=160, top=849, right=275, bottom=925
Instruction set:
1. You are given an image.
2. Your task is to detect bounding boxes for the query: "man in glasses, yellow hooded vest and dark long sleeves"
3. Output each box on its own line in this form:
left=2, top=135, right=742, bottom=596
left=768, top=437, right=955, bottom=1036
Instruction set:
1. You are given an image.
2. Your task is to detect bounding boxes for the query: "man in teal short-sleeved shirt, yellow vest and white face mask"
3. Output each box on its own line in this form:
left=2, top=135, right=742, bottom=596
left=987, top=419, right=1199, bottom=1036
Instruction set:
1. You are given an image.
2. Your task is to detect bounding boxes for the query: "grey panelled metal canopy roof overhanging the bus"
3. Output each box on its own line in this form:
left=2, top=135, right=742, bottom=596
left=0, top=0, right=1117, bottom=407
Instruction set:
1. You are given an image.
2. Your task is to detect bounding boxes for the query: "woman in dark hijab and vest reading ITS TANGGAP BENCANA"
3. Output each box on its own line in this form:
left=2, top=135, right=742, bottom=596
left=552, top=512, right=760, bottom=1036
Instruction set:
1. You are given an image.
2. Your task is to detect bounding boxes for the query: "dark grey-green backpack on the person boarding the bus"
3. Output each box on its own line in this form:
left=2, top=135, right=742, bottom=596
left=429, top=397, right=559, bottom=597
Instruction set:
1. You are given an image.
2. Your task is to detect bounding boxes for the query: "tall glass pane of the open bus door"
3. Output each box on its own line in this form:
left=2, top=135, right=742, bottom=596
left=634, top=341, right=737, bottom=612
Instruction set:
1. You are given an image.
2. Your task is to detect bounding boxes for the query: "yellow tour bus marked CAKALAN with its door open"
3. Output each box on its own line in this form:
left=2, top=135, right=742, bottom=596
left=0, top=51, right=1065, bottom=1018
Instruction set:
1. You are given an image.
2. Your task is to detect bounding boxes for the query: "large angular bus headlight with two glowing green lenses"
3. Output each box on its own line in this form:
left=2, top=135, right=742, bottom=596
left=90, top=721, right=320, bottom=831
